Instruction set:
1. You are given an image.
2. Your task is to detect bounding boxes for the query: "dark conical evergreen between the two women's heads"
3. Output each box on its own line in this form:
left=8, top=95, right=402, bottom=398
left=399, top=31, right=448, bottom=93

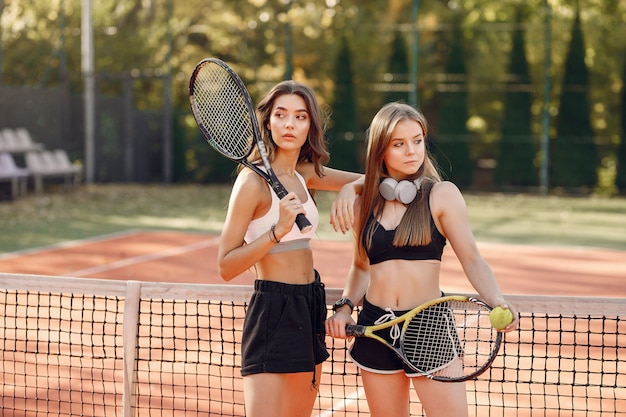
left=328, top=37, right=364, bottom=171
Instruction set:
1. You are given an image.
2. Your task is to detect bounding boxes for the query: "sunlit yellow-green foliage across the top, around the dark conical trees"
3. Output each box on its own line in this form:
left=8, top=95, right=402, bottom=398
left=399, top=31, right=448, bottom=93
left=0, top=0, right=626, bottom=190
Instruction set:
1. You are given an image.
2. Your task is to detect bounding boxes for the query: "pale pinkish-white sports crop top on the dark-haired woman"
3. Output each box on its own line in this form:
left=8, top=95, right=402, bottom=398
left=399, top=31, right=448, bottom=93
left=244, top=172, right=319, bottom=253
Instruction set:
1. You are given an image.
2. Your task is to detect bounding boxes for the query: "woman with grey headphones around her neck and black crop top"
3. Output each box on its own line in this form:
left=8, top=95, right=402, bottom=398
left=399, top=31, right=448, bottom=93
left=326, top=103, right=518, bottom=417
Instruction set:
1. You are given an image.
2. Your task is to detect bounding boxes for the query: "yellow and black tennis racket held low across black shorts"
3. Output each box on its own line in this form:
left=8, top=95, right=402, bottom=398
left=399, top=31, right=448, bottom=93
left=346, top=295, right=502, bottom=382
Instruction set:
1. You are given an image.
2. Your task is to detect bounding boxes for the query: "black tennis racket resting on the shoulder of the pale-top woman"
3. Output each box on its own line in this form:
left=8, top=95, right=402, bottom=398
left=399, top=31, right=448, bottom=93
left=189, top=58, right=313, bottom=233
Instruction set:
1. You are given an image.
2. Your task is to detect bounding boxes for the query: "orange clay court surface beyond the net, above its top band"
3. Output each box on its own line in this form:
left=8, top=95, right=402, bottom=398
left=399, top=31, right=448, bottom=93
left=0, top=230, right=626, bottom=297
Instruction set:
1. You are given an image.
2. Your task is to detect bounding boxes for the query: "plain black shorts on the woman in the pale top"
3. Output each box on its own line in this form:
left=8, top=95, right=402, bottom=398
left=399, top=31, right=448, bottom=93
left=241, top=271, right=329, bottom=376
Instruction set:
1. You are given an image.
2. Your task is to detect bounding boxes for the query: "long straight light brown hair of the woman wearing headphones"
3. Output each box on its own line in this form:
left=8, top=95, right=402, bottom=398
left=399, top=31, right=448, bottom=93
left=355, top=102, right=441, bottom=255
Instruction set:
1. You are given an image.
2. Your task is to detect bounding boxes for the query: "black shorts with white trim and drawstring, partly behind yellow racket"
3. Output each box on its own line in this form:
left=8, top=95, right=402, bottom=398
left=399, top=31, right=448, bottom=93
left=350, top=299, right=462, bottom=377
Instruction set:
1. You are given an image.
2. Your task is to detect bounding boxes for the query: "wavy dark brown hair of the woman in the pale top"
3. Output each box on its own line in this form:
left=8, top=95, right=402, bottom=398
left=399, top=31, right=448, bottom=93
left=248, top=80, right=330, bottom=177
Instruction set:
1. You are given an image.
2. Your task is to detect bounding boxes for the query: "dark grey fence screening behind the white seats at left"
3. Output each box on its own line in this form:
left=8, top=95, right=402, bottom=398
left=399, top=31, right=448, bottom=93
left=0, top=83, right=164, bottom=182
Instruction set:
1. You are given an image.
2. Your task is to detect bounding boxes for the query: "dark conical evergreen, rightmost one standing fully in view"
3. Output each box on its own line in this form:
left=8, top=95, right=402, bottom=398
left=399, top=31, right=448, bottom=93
left=550, top=11, right=598, bottom=191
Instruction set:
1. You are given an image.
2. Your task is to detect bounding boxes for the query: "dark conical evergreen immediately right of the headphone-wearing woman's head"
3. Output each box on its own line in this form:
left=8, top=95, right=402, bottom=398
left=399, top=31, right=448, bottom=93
left=431, top=16, right=473, bottom=187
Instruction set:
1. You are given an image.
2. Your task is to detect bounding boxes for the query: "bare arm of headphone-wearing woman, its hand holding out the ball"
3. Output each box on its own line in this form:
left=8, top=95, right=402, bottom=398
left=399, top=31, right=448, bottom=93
left=430, top=182, right=519, bottom=331
